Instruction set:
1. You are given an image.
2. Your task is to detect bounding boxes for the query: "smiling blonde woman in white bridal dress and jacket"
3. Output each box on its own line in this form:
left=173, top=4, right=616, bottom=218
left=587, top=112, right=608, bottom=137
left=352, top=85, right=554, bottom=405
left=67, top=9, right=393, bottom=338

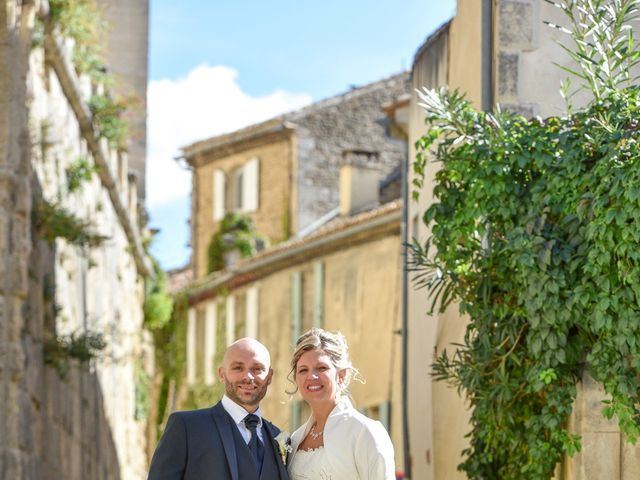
left=288, top=328, right=395, bottom=480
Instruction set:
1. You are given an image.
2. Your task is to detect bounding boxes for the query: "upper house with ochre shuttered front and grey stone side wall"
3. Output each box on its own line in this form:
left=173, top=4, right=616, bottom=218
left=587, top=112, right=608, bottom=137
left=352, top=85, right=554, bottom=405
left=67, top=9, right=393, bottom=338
left=183, top=73, right=409, bottom=278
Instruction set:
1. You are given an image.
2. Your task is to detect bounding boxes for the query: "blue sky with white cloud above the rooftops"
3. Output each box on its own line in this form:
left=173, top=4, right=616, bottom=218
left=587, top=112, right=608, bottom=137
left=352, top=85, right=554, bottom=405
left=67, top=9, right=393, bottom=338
left=147, top=0, right=455, bottom=269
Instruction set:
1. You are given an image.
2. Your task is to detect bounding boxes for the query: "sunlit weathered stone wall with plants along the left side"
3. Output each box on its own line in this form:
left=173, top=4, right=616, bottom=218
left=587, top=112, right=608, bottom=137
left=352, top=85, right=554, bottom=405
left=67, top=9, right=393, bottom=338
left=0, top=0, right=152, bottom=480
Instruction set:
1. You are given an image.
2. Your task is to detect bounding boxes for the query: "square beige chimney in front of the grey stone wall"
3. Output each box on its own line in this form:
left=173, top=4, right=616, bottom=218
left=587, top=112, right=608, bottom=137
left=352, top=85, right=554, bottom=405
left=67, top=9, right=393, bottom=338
left=340, top=152, right=380, bottom=216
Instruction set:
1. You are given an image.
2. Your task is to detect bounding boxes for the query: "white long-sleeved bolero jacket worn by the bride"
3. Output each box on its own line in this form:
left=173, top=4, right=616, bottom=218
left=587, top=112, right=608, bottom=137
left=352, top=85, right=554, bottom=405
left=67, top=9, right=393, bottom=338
left=289, top=398, right=396, bottom=480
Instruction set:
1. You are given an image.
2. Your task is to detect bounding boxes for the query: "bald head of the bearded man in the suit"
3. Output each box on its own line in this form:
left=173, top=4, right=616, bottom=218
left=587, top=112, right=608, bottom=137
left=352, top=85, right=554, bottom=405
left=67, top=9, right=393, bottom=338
left=218, top=337, right=273, bottom=412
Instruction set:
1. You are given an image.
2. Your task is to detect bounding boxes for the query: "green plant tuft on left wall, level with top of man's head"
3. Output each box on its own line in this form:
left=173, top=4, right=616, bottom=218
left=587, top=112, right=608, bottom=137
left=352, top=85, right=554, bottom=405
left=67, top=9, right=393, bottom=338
left=44, top=331, right=107, bottom=378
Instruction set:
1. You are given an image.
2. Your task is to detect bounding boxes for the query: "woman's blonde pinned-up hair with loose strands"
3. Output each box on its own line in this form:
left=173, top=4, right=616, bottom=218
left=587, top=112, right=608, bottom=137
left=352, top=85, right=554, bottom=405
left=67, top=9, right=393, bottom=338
left=287, top=328, right=364, bottom=395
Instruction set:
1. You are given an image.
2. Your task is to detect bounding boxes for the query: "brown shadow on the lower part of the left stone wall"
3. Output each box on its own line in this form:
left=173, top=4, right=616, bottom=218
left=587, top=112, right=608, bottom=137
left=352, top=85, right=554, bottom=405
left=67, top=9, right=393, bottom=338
left=23, top=181, right=121, bottom=480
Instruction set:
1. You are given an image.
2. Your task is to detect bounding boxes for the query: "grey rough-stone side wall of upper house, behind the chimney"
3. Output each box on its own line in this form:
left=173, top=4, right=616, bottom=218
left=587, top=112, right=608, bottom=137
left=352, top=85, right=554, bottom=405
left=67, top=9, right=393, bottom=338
left=286, top=73, right=409, bottom=231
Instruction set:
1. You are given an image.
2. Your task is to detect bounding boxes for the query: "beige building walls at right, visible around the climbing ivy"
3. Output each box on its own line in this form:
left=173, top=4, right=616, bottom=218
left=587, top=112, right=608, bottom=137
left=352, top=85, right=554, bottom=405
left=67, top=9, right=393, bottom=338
left=407, top=0, right=640, bottom=480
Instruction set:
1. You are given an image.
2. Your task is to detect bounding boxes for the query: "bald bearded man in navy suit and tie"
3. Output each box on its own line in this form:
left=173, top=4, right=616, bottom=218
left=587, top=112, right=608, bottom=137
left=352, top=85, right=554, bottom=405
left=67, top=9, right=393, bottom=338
left=148, top=338, right=289, bottom=480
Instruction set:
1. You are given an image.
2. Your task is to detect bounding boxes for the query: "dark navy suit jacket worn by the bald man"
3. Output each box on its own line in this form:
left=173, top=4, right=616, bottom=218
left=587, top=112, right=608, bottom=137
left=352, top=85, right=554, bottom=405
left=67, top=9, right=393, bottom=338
left=148, top=402, right=289, bottom=480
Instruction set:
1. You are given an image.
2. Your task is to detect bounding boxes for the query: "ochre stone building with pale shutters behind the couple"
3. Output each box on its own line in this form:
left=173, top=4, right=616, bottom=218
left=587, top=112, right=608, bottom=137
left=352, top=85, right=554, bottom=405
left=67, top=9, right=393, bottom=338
left=170, top=73, right=408, bottom=468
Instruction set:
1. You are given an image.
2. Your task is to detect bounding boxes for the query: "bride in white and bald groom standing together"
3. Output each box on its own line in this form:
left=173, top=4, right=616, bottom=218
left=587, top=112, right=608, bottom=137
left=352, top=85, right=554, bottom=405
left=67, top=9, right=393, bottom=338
left=148, top=328, right=395, bottom=480
